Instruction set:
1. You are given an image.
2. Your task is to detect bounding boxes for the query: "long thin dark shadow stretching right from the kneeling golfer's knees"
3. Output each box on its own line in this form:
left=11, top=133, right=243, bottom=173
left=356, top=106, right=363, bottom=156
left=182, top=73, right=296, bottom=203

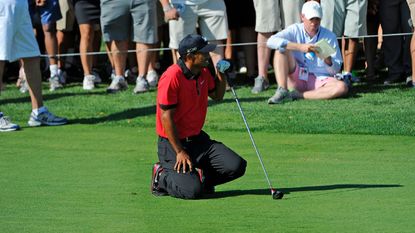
left=204, top=184, right=403, bottom=199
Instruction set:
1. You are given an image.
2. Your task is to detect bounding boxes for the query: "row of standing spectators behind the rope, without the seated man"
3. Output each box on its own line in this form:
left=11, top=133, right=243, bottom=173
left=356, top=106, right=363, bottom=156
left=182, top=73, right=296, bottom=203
left=5, top=0, right=412, bottom=94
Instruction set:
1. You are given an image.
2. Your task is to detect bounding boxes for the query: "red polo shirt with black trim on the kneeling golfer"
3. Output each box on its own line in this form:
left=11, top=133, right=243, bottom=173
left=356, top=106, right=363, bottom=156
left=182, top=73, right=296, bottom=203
left=156, top=64, right=215, bottom=139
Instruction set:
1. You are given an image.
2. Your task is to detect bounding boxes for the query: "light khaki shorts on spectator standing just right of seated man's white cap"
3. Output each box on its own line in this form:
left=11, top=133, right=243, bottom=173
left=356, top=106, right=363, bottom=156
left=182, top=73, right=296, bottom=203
left=321, top=0, right=367, bottom=37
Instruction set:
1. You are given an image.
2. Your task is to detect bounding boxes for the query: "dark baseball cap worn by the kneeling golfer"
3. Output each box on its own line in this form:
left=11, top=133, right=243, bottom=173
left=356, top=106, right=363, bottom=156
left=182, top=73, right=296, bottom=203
left=179, top=35, right=216, bottom=57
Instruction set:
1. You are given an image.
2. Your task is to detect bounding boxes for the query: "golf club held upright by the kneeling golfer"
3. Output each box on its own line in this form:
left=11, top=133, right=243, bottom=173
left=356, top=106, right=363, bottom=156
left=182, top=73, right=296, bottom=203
left=225, top=69, right=284, bottom=199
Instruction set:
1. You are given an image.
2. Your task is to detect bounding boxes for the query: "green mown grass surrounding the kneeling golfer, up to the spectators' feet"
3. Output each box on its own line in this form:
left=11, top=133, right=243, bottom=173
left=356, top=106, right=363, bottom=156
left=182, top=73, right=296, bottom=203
left=0, top=85, right=415, bottom=232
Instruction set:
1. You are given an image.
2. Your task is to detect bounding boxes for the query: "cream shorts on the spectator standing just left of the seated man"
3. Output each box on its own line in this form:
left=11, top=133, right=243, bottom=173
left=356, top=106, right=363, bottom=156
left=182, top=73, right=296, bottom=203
left=254, top=0, right=282, bottom=33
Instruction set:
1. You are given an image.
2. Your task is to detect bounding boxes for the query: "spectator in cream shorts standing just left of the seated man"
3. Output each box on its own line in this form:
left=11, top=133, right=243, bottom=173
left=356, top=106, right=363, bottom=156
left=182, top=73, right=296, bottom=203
left=251, top=0, right=282, bottom=94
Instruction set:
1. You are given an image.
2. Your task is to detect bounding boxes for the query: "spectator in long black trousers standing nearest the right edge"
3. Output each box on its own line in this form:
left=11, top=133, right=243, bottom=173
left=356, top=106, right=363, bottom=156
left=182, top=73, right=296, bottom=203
left=379, top=0, right=412, bottom=85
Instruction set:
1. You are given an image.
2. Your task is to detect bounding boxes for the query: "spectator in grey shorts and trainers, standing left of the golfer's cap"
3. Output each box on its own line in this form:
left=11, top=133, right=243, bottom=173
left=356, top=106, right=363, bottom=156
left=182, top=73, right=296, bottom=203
left=101, top=0, right=157, bottom=93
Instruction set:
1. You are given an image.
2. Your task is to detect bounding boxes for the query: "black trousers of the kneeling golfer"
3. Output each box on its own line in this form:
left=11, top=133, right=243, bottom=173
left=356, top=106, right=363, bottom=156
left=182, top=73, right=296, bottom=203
left=158, top=131, right=247, bottom=199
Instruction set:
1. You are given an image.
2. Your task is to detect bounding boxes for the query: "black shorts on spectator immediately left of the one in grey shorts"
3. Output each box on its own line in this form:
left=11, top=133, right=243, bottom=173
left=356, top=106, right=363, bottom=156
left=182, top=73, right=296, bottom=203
left=74, top=0, right=101, bottom=24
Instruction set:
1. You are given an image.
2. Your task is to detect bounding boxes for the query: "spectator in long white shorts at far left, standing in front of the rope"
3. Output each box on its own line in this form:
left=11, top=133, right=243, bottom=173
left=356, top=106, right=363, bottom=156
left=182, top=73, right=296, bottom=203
left=0, top=0, right=67, bottom=132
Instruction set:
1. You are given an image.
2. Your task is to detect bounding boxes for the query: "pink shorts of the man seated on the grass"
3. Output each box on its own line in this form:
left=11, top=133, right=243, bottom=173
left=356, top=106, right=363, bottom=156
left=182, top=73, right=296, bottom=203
left=289, top=65, right=337, bottom=92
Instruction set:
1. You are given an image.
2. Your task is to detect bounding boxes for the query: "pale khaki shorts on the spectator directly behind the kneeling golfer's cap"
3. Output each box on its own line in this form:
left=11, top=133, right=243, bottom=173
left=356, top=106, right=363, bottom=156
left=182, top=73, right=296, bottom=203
left=169, top=0, right=228, bottom=49
